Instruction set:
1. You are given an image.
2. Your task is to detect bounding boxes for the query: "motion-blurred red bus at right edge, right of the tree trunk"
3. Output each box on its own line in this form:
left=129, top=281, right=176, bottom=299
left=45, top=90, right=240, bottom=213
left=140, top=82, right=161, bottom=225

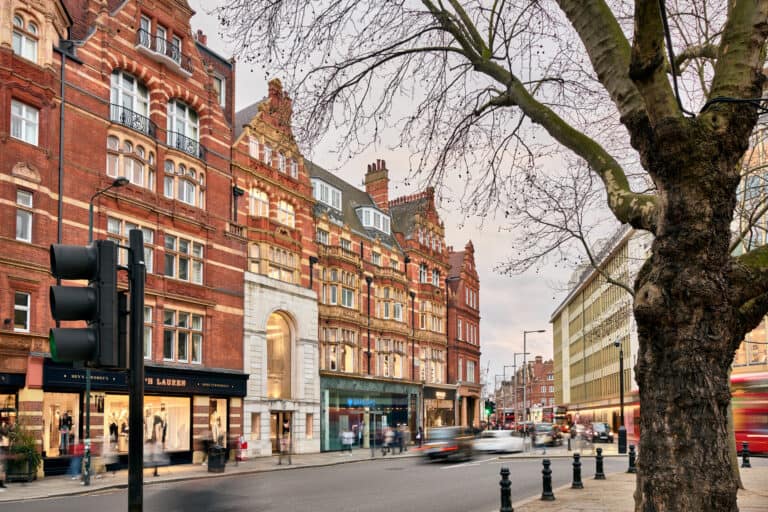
left=731, top=372, right=768, bottom=453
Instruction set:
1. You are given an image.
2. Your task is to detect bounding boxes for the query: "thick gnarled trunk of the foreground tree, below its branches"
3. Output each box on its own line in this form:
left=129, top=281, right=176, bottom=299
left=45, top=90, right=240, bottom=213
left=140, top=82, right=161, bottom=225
left=634, top=125, right=738, bottom=512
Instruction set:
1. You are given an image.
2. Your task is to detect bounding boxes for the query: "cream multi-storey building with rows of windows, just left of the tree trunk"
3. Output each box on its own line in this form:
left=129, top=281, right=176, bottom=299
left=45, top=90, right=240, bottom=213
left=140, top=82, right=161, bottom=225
left=550, top=227, right=652, bottom=437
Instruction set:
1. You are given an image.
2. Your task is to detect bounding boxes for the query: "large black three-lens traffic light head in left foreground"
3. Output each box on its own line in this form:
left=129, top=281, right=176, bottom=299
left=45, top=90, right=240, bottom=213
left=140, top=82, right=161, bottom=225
left=48, top=240, right=124, bottom=367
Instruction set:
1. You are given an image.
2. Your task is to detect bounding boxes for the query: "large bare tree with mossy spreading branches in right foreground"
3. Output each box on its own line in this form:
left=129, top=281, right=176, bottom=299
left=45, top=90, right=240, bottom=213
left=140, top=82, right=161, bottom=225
left=219, top=0, right=768, bottom=512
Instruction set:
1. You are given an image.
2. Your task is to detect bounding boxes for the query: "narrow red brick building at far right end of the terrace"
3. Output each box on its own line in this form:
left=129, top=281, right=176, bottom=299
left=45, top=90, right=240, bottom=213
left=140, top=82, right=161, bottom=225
left=448, top=241, right=482, bottom=427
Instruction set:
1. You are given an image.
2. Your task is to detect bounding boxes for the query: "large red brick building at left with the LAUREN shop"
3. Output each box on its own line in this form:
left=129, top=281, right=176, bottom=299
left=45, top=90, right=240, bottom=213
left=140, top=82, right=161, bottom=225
left=0, top=0, right=247, bottom=473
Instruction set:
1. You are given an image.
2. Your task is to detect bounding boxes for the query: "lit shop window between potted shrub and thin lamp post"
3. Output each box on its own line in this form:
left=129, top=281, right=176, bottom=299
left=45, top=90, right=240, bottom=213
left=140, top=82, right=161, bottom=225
left=43, top=393, right=80, bottom=457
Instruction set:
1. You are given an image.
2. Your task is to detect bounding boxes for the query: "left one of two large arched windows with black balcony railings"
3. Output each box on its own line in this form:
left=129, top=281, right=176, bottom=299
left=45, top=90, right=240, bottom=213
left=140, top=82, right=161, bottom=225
left=109, top=69, right=154, bottom=135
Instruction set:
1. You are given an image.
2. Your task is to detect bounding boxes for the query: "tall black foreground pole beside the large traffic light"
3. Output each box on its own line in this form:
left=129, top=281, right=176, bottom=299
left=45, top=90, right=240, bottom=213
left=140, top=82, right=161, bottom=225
left=128, top=229, right=146, bottom=512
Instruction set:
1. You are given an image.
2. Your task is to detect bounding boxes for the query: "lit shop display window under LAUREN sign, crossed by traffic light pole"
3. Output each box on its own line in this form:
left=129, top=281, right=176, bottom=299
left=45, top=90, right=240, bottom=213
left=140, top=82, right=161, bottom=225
left=104, top=395, right=191, bottom=453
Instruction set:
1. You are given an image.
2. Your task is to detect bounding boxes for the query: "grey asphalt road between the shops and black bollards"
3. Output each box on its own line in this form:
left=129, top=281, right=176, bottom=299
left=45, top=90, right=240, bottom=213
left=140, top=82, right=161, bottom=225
left=9, top=455, right=626, bottom=512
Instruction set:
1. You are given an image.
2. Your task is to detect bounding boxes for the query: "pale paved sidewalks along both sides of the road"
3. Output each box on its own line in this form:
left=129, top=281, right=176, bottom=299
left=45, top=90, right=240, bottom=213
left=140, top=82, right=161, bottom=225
left=0, top=444, right=768, bottom=512
